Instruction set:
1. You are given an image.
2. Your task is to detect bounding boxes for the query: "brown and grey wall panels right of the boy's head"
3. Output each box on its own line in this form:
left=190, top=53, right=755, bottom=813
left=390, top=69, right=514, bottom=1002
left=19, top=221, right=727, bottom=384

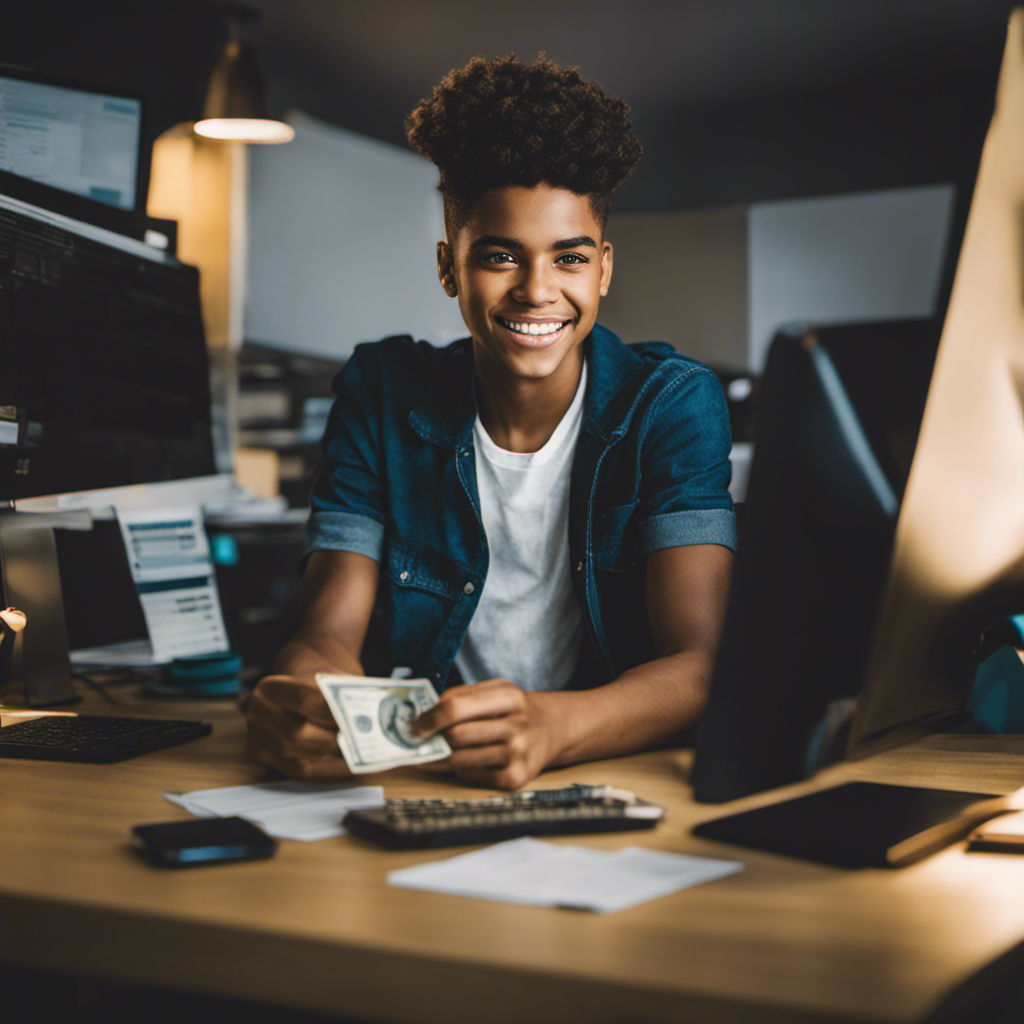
left=600, top=185, right=954, bottom=370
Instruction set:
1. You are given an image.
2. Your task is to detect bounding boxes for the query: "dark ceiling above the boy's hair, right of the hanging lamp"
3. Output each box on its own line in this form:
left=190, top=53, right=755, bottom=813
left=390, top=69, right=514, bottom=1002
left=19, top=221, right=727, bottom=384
left=252, top=0, right=1010, bottom=209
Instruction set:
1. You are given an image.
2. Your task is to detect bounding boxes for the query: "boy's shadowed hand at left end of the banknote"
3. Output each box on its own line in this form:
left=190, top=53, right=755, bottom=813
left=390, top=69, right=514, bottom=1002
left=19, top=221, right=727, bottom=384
left=246, top=676, right=352, bottom=781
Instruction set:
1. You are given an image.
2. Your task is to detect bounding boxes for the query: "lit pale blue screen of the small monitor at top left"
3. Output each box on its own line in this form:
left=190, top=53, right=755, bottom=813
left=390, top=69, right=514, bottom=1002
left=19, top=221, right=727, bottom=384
left=0, top=69, right=142, bottom=210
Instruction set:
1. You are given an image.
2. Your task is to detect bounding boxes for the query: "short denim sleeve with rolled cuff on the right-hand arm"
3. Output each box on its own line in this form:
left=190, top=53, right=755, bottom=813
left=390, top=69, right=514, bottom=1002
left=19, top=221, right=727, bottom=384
left=639, top=365, right=736, bottom=555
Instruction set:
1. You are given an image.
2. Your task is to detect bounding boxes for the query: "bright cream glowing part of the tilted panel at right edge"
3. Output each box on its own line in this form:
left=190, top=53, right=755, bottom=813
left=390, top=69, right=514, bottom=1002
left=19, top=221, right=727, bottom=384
left=880, top=10, right=1024, bottom=598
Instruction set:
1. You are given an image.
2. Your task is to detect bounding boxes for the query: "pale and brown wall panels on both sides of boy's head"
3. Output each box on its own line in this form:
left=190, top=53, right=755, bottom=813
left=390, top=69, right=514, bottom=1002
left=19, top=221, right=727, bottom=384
left=245, top=115, right=953, bottom=370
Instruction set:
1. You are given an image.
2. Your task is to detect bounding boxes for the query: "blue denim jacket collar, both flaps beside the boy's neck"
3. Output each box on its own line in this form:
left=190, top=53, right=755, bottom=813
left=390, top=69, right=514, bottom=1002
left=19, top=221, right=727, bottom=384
left=409, top=324, right=650, bottom=449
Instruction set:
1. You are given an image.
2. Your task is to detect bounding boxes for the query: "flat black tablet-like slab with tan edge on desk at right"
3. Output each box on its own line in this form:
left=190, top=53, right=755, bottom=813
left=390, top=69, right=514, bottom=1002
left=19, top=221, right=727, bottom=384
left=693, top=782, right=1019, bottom=867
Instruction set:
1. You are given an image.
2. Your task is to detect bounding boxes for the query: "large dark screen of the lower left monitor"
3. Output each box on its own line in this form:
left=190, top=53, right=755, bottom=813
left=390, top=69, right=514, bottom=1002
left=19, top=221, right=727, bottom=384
left=0, top=196, right=216, bottom=508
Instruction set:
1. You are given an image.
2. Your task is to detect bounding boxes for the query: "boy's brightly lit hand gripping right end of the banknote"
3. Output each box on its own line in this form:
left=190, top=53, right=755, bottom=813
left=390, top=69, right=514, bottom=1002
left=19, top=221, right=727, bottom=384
left=413, top=679, right=556, bottom=790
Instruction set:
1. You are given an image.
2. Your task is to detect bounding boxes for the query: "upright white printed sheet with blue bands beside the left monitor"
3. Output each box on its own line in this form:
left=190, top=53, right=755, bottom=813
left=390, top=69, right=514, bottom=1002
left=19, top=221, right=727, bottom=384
left=118, top=505, right=228, bottom=663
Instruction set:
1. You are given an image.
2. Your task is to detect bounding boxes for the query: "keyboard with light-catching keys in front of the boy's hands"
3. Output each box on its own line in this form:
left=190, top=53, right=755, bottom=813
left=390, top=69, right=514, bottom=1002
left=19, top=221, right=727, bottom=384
left=342, top=784, right=665, bottom=850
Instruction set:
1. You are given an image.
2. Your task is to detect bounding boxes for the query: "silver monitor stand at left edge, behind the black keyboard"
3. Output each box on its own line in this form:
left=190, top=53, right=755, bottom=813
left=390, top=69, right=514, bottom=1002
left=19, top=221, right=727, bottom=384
left=0, top=510, right=92, bottom=708
